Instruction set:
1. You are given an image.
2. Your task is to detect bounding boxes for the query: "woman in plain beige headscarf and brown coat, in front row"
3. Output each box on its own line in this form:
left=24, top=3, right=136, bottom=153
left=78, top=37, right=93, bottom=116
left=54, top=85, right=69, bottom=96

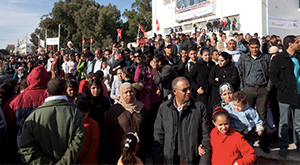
left=100, top=82, right=149, bottom=164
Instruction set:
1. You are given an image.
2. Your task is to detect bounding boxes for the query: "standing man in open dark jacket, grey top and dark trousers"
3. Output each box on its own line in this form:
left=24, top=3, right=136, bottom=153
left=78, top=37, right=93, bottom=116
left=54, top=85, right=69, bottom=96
left=238, top=39, right=271, bottom=153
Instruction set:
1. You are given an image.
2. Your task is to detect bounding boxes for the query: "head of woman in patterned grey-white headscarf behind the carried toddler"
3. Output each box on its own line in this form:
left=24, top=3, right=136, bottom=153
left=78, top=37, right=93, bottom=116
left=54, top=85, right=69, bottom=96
left=216, top=82, right=234, bottom=107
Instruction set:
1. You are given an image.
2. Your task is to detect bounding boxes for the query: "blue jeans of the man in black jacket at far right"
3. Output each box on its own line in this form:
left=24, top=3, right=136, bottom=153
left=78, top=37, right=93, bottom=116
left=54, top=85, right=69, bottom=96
left=278, top=95, right=300, bottom=150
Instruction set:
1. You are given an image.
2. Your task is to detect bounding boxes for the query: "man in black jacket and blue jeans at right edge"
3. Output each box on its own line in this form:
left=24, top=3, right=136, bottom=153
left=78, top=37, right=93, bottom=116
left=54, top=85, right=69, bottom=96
left=270, top=36, right=300, bottom=158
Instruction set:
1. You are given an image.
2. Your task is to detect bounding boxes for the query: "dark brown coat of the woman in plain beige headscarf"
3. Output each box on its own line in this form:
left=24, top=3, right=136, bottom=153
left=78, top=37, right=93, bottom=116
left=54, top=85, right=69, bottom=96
left=100, top=104, right=150, bottom=164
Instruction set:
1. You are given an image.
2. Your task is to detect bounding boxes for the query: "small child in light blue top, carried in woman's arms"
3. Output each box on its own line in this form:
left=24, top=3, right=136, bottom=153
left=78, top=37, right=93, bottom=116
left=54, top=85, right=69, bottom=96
left=224, top=91, right=264, bottom=142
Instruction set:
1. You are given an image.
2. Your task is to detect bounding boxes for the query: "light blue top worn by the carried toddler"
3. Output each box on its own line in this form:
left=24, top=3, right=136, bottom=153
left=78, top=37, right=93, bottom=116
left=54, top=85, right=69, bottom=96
left=224, top=102, right=264, bottom=134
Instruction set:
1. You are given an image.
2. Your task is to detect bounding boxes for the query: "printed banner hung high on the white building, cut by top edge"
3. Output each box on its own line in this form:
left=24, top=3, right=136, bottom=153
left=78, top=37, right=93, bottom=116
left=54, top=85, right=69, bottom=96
left=175, top=0, right=214, bottom=21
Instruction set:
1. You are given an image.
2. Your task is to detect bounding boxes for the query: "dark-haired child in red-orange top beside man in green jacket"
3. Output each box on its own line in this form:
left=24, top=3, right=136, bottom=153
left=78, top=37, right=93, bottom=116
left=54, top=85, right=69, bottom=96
left=75, top=94, right=100, bottom=164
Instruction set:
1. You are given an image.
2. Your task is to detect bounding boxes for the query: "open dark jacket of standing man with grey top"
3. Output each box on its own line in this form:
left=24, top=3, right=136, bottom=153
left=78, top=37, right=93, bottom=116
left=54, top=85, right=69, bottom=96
left=238, top=53, right=272, bottom=89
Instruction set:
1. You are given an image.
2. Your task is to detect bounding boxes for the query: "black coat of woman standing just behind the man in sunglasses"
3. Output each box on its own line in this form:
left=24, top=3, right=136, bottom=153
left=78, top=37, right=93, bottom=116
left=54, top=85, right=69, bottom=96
left=188, top=59, right=215, bottom=106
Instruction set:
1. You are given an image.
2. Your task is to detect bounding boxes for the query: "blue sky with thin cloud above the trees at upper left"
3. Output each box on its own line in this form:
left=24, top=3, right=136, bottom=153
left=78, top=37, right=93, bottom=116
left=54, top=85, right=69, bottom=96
left=0, top=0, right=135, bottom=49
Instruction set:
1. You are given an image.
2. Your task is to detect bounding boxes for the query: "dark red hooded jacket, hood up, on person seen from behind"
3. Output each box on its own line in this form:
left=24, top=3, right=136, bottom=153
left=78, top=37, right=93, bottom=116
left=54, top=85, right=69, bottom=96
left=6, top=66, right=50, bottom=144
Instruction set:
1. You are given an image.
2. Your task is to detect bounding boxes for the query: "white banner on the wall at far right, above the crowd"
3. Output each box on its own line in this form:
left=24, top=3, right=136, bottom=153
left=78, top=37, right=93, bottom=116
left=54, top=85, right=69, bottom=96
left=269, top=16, right=298, bottom=29
